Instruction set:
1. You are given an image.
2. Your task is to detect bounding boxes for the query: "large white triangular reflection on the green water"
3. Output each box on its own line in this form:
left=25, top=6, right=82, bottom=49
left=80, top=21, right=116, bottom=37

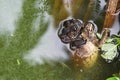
left=24, top=17, right=68, bottom=65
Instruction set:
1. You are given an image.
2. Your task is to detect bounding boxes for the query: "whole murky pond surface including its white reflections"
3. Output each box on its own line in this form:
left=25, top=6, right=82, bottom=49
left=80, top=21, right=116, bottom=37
left=0, top=0, right=120, bottom=80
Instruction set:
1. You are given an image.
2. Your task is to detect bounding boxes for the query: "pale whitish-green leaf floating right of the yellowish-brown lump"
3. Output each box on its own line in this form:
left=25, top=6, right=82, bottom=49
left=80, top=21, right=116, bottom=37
left=101, top=43, right=117, bottom=60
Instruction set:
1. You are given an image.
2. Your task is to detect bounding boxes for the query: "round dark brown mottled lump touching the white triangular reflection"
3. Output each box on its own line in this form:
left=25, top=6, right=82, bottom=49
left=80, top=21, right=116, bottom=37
left=58, top=19, right=83, bottom=43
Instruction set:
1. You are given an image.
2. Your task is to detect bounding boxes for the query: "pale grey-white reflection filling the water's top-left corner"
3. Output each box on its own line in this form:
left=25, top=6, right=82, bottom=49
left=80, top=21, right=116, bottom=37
left=0, top=0, right=23, bottom=33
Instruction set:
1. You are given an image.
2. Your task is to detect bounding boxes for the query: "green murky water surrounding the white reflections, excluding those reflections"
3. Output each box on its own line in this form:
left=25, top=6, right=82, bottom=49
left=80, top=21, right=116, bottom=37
left=0, top=0, right=118, bottom=80
